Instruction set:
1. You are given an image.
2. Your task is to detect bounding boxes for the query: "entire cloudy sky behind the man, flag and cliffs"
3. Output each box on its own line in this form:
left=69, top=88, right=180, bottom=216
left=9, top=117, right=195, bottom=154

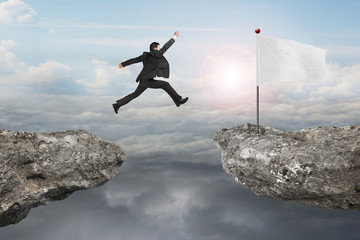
left=0, top=0, right=360, bottom=240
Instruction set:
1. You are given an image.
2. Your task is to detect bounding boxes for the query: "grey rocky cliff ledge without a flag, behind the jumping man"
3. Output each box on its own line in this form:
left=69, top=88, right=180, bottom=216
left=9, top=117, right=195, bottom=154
left=0, top=130, right=125, bottom=227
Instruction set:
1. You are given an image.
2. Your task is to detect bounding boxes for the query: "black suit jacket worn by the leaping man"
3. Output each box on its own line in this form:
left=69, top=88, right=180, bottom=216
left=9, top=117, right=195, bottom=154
left=121, top=38, right=175, bottom=82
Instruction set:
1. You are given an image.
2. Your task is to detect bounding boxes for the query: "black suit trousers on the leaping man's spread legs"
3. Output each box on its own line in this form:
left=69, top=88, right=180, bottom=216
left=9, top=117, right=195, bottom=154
left=116, top=78, right=181, bottom=107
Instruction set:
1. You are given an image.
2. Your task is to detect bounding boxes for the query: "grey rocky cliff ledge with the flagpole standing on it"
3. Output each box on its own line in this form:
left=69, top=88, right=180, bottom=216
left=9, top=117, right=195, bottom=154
left=214, top=124, right=360, bottom=210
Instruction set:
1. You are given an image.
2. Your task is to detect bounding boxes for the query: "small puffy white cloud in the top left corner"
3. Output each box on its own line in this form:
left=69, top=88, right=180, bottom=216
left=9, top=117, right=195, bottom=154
left=0, top=0, right=37, bottom=24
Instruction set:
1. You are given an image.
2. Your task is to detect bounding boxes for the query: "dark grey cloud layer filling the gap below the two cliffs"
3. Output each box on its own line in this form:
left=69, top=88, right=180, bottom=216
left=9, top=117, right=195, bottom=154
left=0, top=154, right=360, bottom=240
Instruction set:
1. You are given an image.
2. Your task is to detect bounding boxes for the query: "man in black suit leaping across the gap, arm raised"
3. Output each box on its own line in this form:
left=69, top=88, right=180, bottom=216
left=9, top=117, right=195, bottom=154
left=113, top=31, right=189, bottom=114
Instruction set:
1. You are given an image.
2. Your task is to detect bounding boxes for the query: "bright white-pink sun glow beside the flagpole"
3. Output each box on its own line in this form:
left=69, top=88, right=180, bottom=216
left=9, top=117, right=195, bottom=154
left=200, top=47, right=256, bottom=108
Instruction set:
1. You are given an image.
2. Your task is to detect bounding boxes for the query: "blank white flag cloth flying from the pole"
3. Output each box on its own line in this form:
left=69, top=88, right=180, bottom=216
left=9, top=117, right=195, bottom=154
left=256, top=35, right=328, bottom=86
